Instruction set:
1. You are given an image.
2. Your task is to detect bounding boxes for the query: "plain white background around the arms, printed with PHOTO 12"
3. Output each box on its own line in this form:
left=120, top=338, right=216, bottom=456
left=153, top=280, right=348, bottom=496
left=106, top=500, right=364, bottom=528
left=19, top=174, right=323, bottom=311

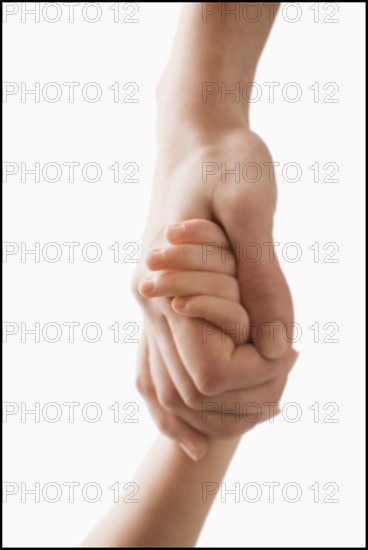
left=4, top=3, right=364, bottom=547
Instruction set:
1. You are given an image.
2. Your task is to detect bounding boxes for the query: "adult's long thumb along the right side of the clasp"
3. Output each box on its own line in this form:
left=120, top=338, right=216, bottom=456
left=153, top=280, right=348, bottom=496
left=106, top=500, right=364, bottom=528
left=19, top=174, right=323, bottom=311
left=214, top=183, right=293, bottom=359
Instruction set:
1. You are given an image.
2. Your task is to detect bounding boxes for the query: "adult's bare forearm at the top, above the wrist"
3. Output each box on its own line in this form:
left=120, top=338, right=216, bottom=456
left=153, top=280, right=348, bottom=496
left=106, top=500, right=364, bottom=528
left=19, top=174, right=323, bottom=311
left=158, top=2, right=279, bottom=137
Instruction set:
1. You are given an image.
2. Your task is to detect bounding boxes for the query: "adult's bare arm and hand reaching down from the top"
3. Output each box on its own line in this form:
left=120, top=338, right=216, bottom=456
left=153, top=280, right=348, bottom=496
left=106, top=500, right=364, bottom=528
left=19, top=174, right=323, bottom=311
left=133, top=4, right=293, bottom=459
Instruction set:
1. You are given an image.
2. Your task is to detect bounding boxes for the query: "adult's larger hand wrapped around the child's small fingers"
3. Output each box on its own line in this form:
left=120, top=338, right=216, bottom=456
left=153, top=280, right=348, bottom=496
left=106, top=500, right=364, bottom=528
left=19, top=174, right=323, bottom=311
left=133, top=128, right=295, bottom=458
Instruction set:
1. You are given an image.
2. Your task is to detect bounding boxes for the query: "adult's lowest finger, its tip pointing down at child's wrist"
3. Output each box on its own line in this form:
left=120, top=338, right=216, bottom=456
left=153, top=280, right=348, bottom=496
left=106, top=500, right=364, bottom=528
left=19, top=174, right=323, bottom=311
left=137, top=330, right=208, bottom=460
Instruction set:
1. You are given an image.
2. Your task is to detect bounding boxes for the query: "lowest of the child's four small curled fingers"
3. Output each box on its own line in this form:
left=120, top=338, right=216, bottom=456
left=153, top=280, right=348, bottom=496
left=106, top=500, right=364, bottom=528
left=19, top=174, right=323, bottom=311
left=171, top=296, right=249, bottom=344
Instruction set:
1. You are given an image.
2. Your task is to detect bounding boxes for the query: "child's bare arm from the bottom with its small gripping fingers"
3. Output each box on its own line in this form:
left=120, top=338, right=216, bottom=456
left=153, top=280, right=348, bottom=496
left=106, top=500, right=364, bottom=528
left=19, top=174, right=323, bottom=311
left=83, top=220, right=295, bottom=548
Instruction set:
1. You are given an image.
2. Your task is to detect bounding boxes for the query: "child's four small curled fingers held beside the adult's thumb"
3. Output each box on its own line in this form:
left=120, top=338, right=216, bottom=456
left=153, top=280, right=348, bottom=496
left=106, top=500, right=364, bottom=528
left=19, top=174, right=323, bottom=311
left=143, top=220, right=249, bottom=344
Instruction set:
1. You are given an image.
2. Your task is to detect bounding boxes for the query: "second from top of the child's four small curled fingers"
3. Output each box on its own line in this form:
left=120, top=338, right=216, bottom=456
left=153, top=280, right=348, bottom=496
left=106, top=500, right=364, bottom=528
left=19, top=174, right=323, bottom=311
left=147, top=243, right=236, bottom=275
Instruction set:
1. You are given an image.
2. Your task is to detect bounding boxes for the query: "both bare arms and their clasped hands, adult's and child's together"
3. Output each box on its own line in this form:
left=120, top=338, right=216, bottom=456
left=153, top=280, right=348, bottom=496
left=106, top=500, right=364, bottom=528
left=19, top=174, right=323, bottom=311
left=85, top=3, right=296, bottom=547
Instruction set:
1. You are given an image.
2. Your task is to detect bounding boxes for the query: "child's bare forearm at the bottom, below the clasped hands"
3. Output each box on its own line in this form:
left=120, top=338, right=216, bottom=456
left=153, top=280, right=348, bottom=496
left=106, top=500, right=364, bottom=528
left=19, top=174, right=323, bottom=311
left=82, top=436, right=239, bottom=548
